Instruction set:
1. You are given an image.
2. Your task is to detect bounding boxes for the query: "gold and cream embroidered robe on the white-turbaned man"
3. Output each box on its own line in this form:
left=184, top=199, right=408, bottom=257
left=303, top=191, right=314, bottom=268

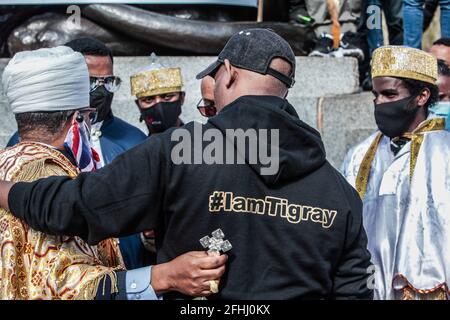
left=0, top=141, right=125, bottom=300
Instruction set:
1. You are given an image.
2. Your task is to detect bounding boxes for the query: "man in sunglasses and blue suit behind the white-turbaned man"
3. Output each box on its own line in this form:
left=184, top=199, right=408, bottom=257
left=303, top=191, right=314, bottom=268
left=66, top=38, right=156, bottom=269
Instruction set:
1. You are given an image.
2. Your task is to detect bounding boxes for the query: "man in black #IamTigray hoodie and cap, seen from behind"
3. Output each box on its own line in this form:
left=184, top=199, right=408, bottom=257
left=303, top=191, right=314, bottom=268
left=0, top=29, right=373, bottom=299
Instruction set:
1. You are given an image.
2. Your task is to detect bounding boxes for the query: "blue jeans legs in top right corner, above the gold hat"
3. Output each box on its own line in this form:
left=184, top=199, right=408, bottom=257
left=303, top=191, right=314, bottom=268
left=403, top=0, right=450, bottom=49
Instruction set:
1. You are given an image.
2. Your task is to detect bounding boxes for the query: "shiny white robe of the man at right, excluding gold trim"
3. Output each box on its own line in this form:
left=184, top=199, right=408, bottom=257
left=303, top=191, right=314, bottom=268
left=342, top=118, right=450, bottom=299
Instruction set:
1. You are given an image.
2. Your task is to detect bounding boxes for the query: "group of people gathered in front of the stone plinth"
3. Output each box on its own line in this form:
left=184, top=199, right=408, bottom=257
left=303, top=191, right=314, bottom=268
left=0, top=8, right=450, bottom=300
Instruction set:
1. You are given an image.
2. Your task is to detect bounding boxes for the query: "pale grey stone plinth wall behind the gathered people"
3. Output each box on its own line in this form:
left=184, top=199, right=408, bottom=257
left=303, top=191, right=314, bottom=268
left=0, top=57, right=376, bottom=166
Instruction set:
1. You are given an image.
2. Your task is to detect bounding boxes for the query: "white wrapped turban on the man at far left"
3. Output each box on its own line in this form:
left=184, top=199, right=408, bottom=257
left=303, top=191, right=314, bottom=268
left=2, top=46, right=89, bottom=114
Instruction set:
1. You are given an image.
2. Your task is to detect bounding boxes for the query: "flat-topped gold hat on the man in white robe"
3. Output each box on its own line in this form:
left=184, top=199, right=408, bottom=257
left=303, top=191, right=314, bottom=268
left=371, top=46, right=438, bottom=85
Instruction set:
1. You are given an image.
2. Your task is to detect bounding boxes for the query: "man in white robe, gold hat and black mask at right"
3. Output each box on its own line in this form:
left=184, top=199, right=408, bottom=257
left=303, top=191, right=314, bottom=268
left=342, top=46, right=450, bottom=299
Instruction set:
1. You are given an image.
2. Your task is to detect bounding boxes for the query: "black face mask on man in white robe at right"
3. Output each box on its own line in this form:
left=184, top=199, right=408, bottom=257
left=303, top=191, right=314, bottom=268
left=375, top=95, right=419, bottom=138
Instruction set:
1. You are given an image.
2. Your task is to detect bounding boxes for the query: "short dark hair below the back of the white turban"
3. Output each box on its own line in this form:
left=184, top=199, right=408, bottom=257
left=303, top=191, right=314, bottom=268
left=15, top=110, right=74, bottom=137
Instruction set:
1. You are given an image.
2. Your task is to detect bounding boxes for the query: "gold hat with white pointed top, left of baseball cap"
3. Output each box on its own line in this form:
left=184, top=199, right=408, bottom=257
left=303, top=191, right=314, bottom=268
left=130, top=53, right=183, bottom=98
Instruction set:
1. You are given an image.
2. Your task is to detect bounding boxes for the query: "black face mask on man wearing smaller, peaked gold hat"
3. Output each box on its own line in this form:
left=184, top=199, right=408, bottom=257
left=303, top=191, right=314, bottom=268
left=139, top=100, right=181, bottom=133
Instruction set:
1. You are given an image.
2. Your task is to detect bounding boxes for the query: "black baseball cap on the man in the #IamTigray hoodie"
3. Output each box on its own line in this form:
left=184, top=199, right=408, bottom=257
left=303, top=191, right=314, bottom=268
left=197, top=28, right=295, bottom=88
